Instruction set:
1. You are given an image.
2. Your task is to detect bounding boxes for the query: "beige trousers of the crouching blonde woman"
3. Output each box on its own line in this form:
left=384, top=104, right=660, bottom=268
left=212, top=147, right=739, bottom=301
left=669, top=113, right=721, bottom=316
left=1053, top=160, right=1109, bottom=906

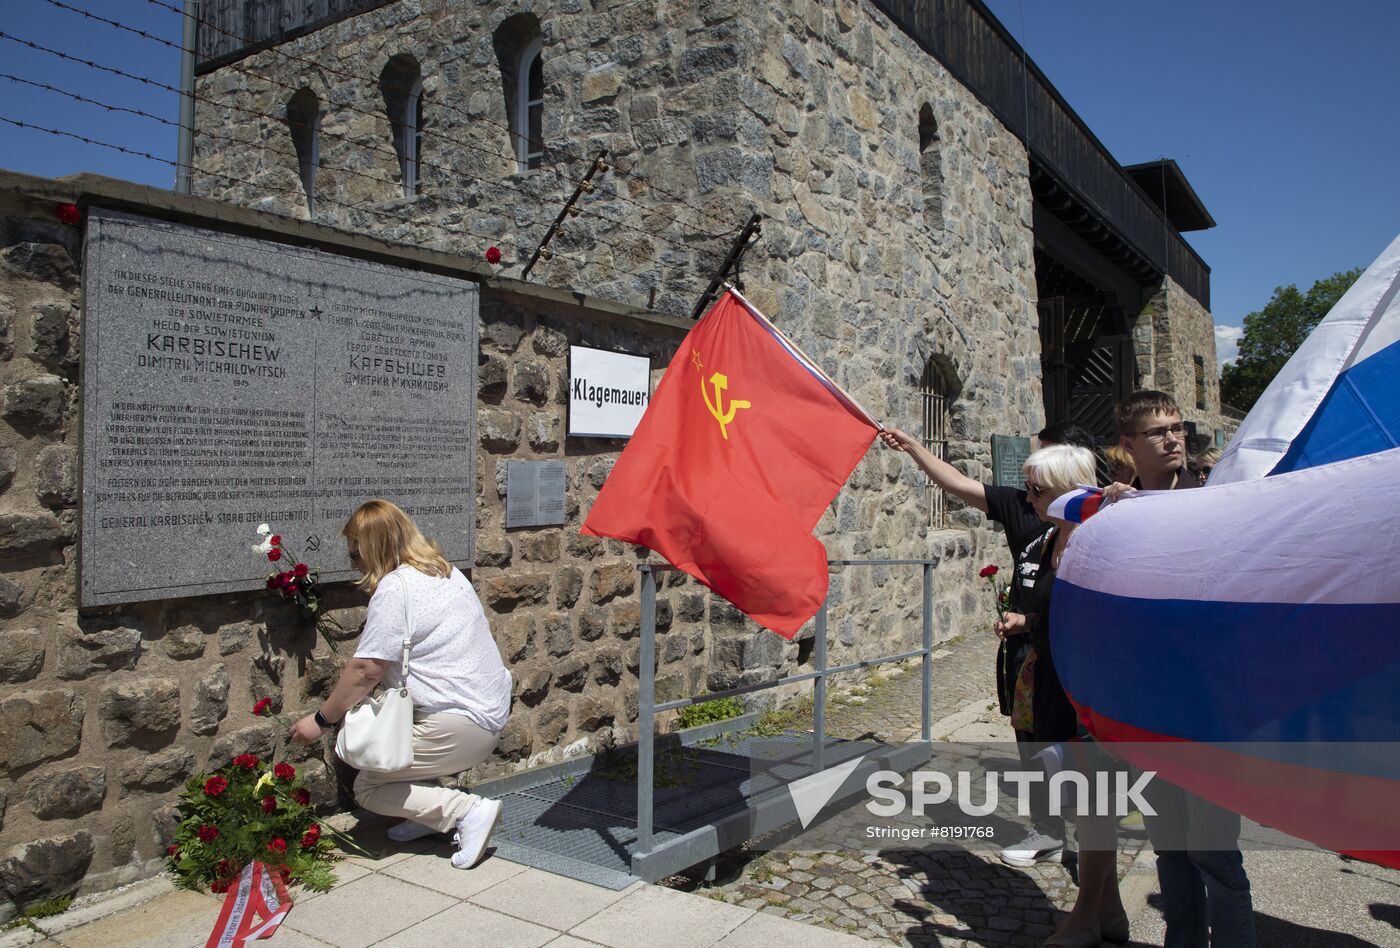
left=354, top=711, right=497, bottom=833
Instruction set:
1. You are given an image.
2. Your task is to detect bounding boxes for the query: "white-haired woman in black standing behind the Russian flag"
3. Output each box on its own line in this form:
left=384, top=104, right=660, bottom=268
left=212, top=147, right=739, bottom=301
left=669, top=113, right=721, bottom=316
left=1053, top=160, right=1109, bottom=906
left=995, top=445, right=1128, bottom=948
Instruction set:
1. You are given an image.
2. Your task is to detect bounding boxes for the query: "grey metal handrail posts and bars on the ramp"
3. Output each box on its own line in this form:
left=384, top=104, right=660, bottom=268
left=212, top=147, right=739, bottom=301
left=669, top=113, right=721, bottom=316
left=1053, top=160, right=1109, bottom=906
left=637, top=560, right=938, bottom=854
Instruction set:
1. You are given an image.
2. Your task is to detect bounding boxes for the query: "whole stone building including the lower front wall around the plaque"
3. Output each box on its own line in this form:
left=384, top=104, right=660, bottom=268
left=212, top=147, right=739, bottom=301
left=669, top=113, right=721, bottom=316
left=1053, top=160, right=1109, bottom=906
left=0, top=0, right=1224, bottom=900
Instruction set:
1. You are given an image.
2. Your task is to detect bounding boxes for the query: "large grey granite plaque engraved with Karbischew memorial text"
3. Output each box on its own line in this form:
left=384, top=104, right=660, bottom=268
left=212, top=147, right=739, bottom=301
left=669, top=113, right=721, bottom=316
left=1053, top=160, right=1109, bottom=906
left=80, top=210, right=477, bottom=606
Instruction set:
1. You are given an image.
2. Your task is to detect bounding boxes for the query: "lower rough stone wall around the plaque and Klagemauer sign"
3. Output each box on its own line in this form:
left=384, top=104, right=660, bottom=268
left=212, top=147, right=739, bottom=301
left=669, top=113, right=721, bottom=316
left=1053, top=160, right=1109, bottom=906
left=0, top=170, right=1004, bottom=914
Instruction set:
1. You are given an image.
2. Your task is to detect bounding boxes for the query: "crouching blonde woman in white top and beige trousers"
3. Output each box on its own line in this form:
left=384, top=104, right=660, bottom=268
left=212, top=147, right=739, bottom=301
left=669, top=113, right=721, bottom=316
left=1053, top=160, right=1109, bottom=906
left=291, top=500, right=511, bottom=870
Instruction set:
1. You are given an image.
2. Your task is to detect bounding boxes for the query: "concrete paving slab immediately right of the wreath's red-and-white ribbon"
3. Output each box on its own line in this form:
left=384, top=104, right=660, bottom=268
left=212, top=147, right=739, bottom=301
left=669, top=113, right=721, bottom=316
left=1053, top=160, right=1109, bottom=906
left=281, top=872, right=454, bottom=948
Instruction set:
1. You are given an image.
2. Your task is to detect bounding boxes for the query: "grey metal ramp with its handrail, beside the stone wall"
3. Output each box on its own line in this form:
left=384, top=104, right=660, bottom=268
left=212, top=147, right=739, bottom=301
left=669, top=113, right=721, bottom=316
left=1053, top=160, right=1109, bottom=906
left=476, top=560, right=937, bottom=889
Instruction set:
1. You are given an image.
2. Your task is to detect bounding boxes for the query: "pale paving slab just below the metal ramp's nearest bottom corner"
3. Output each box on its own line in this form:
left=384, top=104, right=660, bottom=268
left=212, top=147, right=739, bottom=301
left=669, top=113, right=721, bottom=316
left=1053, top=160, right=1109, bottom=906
left=568, top=885, right=755, bottom=948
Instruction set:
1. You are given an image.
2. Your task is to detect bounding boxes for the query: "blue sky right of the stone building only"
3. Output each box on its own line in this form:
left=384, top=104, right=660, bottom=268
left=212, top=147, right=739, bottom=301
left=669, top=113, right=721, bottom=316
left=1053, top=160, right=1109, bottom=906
left=987, top=0, right=1400, bottom=357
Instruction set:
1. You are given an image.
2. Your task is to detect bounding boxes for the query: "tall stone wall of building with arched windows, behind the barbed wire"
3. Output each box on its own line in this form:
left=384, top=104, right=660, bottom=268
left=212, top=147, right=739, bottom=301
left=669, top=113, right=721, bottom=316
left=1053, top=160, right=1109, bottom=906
left=196, top=0, right=1043, bottom=649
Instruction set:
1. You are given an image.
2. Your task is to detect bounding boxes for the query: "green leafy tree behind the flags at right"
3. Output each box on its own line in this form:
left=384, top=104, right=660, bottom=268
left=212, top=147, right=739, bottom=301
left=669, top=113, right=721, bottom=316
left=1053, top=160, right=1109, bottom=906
left=1221, top=267, right=1361, bottom=412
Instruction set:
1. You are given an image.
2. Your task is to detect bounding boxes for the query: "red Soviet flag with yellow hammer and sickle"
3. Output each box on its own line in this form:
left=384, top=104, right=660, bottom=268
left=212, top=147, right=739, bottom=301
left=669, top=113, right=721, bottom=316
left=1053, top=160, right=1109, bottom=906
left=582, top=290, right=879, bottom=639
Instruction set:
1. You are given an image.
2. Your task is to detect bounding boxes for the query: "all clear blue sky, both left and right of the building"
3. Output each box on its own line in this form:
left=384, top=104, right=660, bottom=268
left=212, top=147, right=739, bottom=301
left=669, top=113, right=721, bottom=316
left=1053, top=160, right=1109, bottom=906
left=0, top=0, right=1400, bottom=366
